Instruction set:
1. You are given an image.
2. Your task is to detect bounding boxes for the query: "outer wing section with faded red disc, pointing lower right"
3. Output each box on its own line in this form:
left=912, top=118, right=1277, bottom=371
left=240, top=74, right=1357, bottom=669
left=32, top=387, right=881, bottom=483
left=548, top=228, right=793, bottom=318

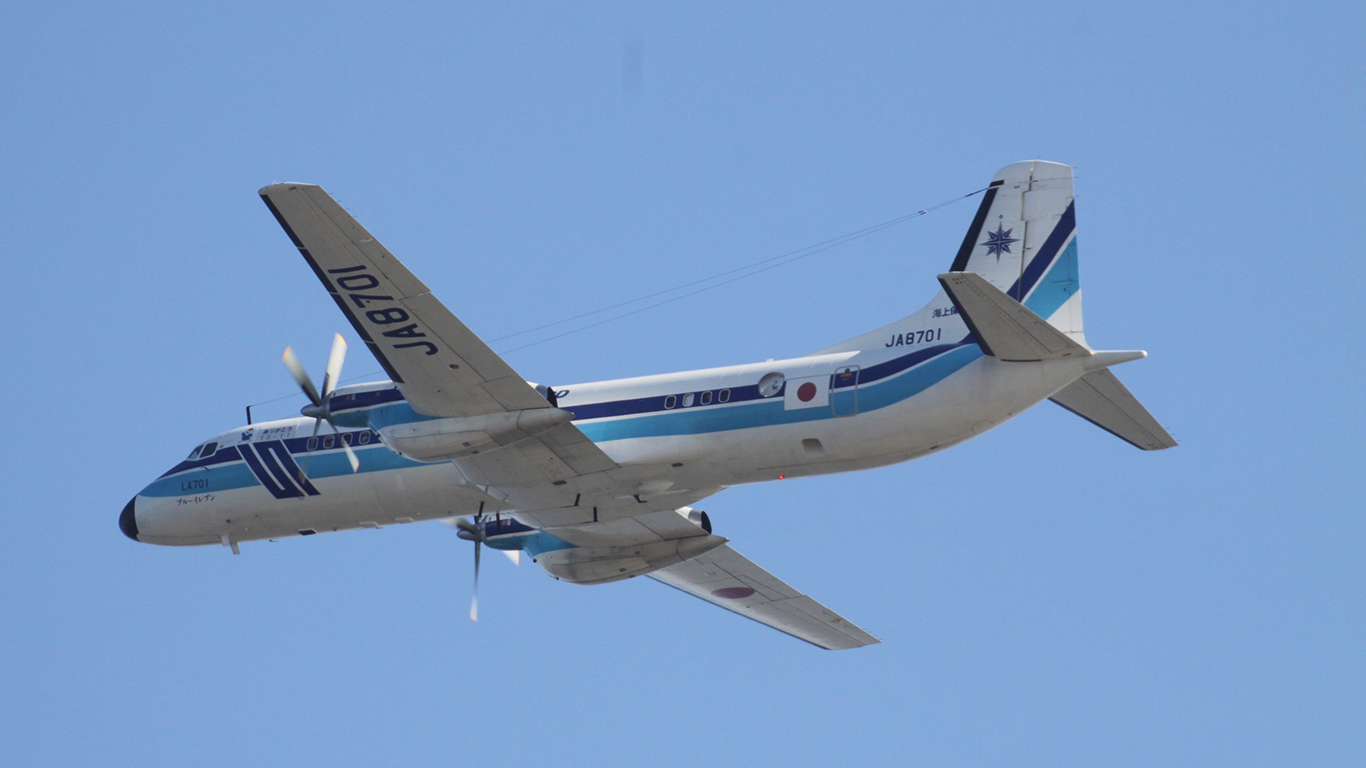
left=650, top=545, right=881, bottom=650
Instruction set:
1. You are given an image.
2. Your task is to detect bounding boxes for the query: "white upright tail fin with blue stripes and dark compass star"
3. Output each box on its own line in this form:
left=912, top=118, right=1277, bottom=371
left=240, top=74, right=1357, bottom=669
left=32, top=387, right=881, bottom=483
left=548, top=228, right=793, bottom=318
left=949, top=160, right=1086, bottom=346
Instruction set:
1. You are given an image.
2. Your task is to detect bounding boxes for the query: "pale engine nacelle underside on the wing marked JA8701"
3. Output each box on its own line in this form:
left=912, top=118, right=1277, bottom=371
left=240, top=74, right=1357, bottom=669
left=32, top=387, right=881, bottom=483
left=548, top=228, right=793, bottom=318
left=380, top=407, right=574, bottom=462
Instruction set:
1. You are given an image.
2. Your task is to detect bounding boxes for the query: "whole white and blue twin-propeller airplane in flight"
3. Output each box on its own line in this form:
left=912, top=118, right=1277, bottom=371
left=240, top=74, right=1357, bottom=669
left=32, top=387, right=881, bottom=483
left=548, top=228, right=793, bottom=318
left=119, top=160, right=1176, bottom=649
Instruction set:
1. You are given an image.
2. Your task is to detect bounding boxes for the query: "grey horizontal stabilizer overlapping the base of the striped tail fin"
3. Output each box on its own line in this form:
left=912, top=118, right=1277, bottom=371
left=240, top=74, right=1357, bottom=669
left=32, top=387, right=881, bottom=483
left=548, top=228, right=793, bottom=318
left=938, top=272, right=1091, bottom=362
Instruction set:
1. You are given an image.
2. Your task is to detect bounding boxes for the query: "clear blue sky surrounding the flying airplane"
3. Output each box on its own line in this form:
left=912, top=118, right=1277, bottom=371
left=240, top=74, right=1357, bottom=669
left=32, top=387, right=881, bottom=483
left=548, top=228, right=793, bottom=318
left=0, top=1, right=1366, bottom=767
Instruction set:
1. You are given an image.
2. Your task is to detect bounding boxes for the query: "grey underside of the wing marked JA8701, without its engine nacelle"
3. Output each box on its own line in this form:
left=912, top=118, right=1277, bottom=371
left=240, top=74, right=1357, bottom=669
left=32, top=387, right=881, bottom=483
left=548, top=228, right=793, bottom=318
left=261, top=183, right=638, bottom=513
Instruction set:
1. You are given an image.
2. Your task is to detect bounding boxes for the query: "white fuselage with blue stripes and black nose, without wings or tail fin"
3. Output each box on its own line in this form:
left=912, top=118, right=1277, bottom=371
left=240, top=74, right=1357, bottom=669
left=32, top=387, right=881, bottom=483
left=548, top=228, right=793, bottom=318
left=125, top=333, right=1086, bottom=545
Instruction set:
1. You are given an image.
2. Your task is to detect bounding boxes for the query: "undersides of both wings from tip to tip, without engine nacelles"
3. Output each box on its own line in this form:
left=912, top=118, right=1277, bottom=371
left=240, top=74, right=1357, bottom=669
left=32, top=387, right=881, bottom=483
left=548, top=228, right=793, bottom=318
left=261, top=184, right=878, bottom=649
